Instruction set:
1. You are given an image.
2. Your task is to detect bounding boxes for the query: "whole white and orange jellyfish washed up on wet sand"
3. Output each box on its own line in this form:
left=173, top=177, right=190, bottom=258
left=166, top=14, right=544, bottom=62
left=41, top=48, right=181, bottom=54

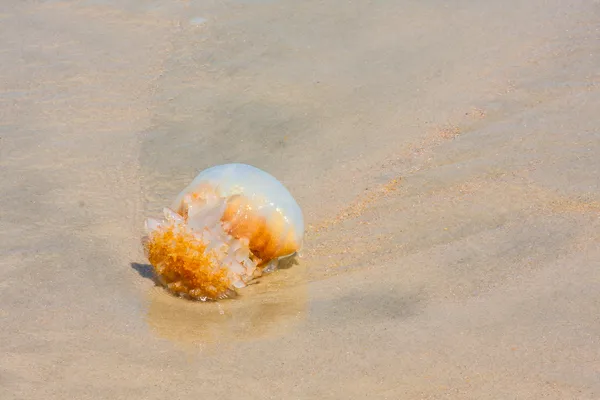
left=144, top=164, right=304, bottom=301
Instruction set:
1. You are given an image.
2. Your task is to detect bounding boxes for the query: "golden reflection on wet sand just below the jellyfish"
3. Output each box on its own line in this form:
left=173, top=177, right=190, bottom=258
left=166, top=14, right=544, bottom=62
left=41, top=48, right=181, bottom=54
left=146, top=264, right=308, bottom=345
